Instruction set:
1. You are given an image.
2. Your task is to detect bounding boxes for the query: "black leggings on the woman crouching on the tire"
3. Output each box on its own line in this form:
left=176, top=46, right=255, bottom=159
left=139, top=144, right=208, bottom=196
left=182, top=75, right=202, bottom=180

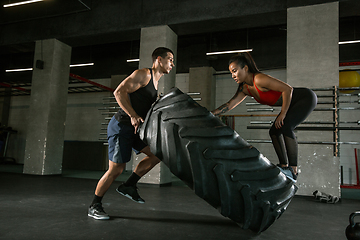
left=269, top=88, right=317, bottom=166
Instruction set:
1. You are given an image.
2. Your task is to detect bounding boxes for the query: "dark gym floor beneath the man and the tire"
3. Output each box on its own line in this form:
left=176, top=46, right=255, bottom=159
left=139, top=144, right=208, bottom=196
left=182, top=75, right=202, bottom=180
left=0, top=168, right=360, bottom=240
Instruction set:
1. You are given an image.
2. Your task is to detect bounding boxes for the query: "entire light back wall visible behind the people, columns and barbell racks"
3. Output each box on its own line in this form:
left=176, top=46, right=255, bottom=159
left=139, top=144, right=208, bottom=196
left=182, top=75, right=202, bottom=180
left=4, top=73, right=360, bottom=188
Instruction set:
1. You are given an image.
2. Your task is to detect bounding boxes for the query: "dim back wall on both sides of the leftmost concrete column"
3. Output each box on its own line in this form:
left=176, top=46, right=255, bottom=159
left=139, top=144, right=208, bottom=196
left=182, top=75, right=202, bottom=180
left=7, top=79, right=110, bottom=163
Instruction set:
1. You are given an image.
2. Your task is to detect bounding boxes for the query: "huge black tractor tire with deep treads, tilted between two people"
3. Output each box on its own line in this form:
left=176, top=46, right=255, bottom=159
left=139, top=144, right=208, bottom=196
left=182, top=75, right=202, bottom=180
left=139, top=88, right=298, bottom=233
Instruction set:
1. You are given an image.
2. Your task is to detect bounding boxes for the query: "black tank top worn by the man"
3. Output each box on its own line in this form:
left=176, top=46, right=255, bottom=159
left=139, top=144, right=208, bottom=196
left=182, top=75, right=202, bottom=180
left=115, top=68, right=157, bottom=125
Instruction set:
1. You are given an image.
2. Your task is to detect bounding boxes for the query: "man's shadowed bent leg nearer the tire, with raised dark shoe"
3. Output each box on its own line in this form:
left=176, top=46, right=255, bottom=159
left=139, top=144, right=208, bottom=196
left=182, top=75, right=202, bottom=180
left=116, top=146, right=160, bottom=203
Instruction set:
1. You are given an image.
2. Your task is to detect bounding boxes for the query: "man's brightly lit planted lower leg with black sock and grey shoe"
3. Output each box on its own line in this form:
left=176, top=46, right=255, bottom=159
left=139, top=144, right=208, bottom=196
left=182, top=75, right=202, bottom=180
left=88, top=160, right=126, bottom=219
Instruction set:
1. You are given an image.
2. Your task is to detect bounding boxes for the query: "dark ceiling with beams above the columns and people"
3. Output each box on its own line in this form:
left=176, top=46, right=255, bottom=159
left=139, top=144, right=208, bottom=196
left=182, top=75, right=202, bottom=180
left=0, top=0, right=360, bottom=86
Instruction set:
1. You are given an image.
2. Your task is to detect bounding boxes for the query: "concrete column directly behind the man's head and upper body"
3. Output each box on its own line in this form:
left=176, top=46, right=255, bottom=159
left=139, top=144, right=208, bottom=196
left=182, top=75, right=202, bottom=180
left=133, top=26, right=177, bottom=185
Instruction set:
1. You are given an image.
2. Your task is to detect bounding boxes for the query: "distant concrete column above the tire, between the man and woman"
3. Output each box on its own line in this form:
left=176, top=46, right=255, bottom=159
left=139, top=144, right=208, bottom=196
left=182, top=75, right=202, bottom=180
left=189, top=67, right=216, bottom=111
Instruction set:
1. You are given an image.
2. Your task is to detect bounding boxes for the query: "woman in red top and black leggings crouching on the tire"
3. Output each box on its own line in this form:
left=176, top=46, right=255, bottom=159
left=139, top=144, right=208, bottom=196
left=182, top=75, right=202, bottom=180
left=212, top=53, right=317, bottom=181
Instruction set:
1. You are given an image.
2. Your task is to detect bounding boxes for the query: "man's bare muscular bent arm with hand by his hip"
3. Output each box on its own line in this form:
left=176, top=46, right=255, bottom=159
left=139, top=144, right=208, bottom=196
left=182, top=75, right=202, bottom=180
left=113, top=69, right=151, bottom=133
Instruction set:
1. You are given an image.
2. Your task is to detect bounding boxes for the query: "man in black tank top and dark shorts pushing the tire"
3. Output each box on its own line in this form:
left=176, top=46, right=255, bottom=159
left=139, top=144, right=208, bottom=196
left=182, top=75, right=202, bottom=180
left=88, top=47, right=175, bottom=219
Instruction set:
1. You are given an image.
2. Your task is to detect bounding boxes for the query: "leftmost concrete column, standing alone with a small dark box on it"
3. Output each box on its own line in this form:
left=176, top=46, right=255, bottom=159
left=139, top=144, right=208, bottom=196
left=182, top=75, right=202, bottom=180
left=23, top=39, right=71, bottom=175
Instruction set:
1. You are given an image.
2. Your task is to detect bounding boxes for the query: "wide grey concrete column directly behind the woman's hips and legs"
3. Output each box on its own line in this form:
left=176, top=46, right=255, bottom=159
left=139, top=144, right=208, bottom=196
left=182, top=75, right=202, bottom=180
left=287, top=2, right=340, bottom=196
